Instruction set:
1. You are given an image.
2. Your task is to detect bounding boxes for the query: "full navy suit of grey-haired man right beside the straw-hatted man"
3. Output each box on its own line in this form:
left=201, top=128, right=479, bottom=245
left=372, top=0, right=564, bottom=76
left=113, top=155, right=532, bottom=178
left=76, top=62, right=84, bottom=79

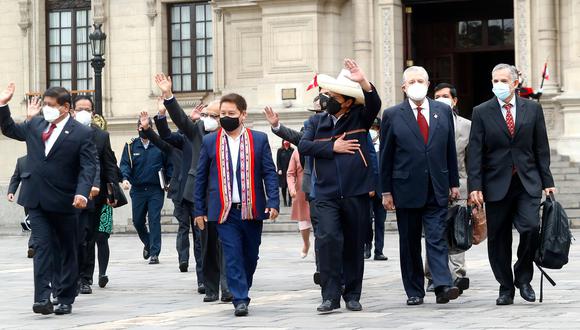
left=380, top=98, right=459, bottom=297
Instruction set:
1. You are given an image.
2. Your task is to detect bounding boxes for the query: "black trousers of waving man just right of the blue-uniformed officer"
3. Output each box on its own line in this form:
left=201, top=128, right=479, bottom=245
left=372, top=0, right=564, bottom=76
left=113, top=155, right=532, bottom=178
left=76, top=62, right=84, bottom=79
left=173, top=200, right=204, bottom=284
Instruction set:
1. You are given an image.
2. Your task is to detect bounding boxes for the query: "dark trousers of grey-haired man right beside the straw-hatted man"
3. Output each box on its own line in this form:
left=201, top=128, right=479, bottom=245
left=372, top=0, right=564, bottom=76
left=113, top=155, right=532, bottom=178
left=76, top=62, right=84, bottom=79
left=396, top=185, right=452, bottom=298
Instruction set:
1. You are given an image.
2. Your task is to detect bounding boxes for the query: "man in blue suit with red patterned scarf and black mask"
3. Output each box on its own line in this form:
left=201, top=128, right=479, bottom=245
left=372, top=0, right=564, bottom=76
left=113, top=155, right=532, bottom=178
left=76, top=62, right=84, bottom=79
left=194, top=94, right=280, bottom=316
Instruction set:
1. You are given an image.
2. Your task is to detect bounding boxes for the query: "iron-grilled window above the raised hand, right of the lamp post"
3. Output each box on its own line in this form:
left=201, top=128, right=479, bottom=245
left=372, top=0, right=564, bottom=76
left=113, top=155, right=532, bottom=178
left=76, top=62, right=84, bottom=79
left=168, top=2, right=213, bottom=92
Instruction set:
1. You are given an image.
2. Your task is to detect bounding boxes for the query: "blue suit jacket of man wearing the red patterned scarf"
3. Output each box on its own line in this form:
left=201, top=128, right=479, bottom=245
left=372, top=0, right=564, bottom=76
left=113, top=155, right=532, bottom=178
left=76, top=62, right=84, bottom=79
left=194, top=130, right=280, bottom=221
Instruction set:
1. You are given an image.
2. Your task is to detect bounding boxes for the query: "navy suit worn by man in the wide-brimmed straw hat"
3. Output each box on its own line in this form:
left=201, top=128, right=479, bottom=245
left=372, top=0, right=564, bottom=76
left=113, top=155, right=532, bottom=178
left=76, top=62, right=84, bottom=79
left=298, top=86, right=381, bottom=305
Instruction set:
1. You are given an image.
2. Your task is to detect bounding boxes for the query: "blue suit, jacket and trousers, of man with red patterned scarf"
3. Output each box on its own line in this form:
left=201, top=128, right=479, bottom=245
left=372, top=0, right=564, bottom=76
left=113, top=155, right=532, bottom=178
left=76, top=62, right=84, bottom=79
left=194, top=130, right=280, bottom=305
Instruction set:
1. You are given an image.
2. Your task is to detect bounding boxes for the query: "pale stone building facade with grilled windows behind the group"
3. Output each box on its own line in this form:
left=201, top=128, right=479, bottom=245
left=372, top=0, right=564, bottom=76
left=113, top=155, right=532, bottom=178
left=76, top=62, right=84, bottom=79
left=0, top=0, right=580, bottom=229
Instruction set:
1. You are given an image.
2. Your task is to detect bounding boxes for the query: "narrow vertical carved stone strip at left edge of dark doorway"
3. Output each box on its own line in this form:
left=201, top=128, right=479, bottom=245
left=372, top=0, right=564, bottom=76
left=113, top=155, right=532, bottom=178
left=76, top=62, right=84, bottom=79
left=382, top=7, right=395, bottom=104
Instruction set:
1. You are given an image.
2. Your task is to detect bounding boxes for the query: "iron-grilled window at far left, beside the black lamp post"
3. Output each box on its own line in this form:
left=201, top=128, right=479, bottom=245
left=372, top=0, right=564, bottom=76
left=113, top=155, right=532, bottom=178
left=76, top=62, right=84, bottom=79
left=46, top=0, right=93, bottom=90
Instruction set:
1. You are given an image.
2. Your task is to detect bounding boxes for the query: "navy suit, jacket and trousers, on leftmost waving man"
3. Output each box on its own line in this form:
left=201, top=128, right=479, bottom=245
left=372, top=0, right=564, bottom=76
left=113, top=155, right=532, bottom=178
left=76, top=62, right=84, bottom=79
left=0, top=106, right=97, bottom=304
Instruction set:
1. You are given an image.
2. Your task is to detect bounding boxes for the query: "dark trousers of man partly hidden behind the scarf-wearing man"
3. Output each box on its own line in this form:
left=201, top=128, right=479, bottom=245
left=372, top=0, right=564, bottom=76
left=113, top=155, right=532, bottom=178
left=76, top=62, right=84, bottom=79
left=201, top=221, right=229, bottom=294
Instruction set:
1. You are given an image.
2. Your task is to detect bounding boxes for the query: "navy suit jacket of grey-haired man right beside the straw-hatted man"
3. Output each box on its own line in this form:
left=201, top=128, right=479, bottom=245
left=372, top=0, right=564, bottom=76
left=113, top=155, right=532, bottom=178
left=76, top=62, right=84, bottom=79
left=379, top=99, right=459, bottom=208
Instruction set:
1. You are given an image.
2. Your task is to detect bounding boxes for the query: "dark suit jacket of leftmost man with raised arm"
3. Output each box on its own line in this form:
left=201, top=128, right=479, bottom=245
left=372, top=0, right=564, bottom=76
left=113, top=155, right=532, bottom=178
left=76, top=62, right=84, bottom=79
left=0, top=105, right=97, bottom=213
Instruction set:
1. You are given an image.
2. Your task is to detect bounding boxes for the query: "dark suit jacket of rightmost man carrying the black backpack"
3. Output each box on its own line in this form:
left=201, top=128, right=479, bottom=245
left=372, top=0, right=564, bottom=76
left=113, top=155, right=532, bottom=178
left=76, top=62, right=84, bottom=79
left=467, top=97, right=554, bottom=202
